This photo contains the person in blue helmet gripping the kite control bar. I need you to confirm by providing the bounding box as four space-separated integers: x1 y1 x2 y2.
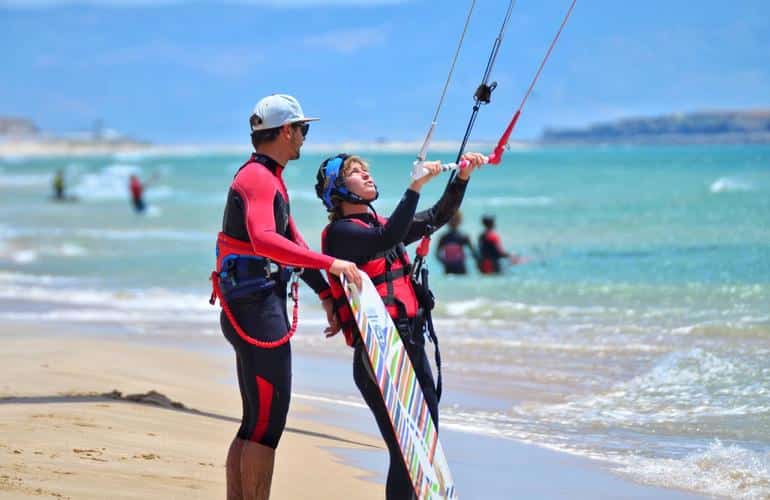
316 153 484 500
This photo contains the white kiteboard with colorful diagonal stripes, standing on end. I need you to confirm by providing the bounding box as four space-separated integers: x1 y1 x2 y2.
343 273 457 499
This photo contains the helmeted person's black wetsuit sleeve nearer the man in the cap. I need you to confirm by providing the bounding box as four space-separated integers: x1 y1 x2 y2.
326 189 420 263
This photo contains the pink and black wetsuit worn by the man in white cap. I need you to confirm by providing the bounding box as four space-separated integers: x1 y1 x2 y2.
220 154 334 448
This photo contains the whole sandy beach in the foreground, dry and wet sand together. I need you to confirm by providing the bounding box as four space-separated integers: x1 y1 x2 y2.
0 316 695 500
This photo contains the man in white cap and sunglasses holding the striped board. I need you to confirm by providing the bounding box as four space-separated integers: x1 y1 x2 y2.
212 95 361 500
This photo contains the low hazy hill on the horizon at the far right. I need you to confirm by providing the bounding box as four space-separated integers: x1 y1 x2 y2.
541 110 770 144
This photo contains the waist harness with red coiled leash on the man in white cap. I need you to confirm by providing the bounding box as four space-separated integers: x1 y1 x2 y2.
209 232 302 349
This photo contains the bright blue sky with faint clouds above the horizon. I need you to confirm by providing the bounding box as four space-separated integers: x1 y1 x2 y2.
0 0 770 144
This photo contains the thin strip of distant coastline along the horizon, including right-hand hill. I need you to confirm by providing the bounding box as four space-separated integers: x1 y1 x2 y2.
6 109 770 157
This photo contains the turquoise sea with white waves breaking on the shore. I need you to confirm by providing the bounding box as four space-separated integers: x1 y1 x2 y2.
0 146 770 498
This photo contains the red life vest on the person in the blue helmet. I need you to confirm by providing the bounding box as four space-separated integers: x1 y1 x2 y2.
321 217 419 346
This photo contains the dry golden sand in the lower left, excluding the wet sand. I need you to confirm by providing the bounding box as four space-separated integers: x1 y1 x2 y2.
0 327 381 499
